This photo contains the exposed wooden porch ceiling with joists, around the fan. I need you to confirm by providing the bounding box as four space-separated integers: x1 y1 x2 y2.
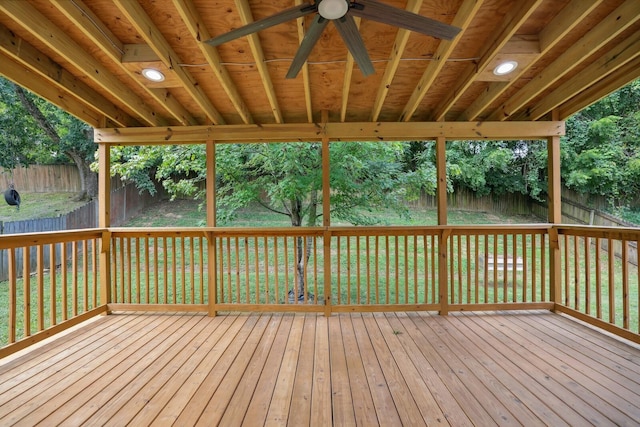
0 0 640 127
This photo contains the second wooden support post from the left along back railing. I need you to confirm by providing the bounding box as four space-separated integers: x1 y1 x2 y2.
206 141 218 316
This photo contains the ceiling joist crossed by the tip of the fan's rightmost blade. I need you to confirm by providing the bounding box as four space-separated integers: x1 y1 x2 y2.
399 0 484 122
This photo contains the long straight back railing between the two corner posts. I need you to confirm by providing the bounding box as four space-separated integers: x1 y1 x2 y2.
111 225 552 313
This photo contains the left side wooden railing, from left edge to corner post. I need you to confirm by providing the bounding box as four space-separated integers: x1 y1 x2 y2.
0 230 106 357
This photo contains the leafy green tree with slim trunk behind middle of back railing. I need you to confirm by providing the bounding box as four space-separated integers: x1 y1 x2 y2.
112 142 436 298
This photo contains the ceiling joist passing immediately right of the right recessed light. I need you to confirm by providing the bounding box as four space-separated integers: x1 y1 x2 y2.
458 0 604 121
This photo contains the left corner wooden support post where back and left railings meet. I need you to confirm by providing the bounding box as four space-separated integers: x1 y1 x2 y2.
98 144 112 314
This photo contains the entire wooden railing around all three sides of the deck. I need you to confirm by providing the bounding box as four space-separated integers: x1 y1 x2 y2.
0 224 640 356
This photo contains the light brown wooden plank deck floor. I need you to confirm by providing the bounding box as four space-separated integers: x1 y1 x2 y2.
0 311 640 426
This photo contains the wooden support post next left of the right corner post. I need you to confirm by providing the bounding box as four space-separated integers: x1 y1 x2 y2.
436 137 451 316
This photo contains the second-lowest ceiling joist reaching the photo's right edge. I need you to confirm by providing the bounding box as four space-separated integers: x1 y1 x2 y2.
515 31 640 120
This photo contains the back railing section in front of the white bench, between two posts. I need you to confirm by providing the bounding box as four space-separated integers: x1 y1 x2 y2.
447 225 551 310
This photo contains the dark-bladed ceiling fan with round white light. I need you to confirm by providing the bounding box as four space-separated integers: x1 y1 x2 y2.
205 0 460 79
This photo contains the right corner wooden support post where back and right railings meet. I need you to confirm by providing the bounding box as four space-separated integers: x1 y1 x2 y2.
547 120 562 304
